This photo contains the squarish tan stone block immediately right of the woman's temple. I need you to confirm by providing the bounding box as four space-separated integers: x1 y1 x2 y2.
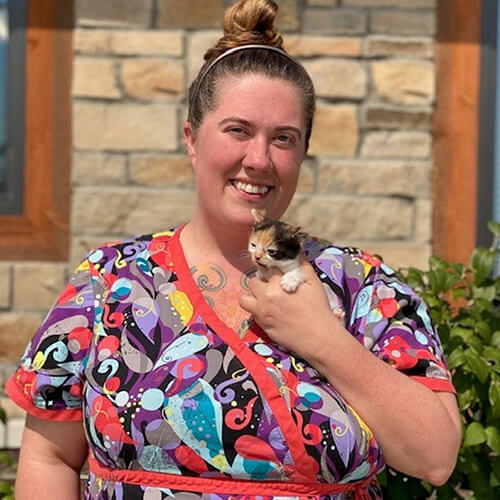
309 104 359 156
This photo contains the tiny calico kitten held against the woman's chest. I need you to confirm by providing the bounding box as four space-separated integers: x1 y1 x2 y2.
248 208 307 293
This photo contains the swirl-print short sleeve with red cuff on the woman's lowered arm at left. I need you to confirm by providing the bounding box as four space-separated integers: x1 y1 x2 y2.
6 254 99 421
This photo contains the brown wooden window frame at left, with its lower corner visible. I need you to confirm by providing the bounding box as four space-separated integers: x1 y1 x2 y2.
0 0 74 261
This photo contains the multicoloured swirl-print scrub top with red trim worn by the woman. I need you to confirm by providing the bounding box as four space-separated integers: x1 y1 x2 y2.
7 228 454 500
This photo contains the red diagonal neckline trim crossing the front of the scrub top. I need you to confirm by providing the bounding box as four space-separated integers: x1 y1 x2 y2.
170 226 318 482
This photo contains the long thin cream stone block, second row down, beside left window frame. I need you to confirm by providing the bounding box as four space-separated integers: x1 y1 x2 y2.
73 28 184 57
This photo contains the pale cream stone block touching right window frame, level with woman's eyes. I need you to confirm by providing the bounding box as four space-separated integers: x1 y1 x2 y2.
361 131 431 159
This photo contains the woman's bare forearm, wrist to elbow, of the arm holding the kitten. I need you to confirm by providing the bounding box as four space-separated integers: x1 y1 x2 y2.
308 318 460 483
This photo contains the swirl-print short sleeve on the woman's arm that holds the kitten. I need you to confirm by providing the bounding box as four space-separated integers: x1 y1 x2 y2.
348 254 456 393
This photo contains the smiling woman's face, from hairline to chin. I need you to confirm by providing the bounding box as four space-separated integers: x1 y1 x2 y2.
184 74 306 229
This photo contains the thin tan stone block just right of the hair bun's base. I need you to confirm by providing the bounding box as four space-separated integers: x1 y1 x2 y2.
284 35 362 57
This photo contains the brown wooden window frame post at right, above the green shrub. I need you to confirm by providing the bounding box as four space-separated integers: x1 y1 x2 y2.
432 0 483 264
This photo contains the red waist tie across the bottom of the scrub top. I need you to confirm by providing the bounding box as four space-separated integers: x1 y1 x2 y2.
89 457 375 500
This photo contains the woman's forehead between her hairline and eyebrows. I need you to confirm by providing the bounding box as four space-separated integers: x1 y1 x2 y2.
210 74 304 127
